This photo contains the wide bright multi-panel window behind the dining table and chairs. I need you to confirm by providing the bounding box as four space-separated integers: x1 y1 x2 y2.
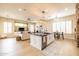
52 21 72 34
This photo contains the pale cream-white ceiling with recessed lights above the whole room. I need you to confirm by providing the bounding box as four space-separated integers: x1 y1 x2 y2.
0 3 76 20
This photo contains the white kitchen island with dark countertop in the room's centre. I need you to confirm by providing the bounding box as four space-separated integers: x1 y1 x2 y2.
30 33 53 50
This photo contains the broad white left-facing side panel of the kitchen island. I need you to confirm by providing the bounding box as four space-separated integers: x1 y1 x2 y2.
30 34 42 50
